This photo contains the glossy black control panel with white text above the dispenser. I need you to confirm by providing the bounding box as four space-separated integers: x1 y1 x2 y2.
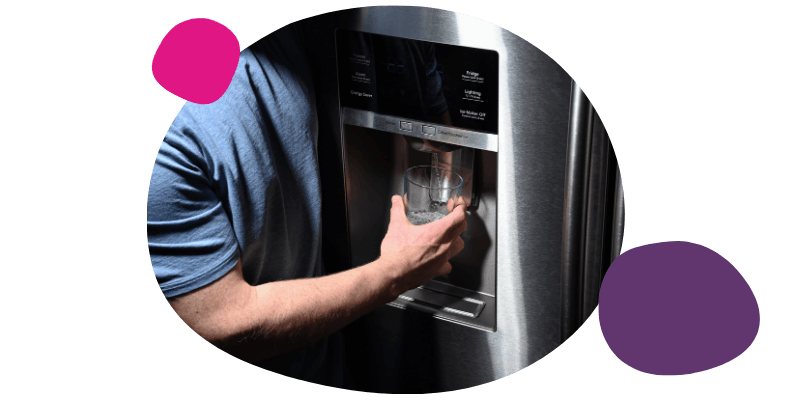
336 29 498 134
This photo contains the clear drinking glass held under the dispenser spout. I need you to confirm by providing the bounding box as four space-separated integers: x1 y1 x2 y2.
403 165 464 225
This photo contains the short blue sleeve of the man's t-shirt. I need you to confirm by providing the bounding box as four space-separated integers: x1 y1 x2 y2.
147 120 239 298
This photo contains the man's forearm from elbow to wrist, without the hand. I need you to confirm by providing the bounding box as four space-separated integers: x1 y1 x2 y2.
215 260 397 362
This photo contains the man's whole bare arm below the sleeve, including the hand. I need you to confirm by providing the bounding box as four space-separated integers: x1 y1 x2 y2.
170 196 466 362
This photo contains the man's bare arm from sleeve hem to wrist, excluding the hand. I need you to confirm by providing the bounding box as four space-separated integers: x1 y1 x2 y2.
170 260 393 362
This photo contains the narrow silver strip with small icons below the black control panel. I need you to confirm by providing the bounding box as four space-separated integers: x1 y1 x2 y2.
342 108 497 152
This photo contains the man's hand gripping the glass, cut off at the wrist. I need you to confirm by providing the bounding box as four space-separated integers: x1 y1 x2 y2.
379 196 467 299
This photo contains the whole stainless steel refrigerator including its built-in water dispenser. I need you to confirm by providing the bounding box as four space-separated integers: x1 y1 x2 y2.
301 7 623 392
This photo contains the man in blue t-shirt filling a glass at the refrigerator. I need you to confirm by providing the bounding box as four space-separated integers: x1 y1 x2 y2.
147 24 466 387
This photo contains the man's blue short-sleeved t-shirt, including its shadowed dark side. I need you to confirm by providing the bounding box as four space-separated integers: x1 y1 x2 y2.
147 24 343 387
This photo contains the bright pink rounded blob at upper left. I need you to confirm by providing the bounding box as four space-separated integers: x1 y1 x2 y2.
153 18 239 104
